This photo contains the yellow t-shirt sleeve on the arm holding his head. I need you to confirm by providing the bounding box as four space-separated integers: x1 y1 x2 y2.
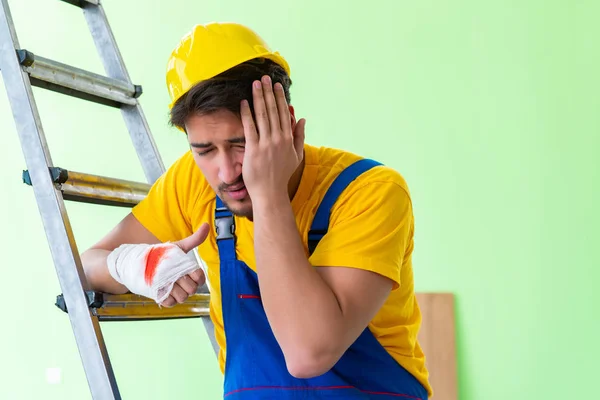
309 176 413 289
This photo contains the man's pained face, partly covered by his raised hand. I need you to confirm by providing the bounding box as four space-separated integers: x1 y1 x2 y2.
185 110 252 218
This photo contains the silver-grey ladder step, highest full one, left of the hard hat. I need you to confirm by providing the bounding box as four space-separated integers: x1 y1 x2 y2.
17 49 142 107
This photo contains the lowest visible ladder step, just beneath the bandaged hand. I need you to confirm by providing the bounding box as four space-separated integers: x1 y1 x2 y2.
56 292 210 321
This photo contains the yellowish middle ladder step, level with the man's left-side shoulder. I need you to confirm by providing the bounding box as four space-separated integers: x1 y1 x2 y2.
23 167 151 207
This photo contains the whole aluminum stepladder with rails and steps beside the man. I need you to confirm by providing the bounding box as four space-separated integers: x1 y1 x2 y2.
0 0 217 400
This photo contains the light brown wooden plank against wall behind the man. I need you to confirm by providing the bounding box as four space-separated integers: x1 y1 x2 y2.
417 293 458 400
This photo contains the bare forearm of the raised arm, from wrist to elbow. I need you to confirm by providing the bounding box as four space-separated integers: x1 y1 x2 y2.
254 196 344 372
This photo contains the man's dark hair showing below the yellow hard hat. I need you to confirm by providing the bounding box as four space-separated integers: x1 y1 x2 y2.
169 58 292 130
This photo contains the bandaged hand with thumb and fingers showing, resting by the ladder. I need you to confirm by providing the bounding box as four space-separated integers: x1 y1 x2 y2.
107 224 209 307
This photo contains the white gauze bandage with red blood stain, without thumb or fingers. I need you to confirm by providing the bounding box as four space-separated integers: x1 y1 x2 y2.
106 243 200 304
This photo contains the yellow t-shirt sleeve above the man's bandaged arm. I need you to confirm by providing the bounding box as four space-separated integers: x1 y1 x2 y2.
132 153 201 242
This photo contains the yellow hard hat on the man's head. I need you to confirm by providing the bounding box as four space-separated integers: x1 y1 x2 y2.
167 22 290 109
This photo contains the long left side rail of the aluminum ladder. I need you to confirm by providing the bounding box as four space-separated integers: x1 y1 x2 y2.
0 0 120 399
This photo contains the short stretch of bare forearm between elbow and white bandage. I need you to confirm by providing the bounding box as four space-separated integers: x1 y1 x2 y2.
81 249 128 294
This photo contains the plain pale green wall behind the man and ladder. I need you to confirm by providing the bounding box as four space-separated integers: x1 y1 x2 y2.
0 0 600 400
